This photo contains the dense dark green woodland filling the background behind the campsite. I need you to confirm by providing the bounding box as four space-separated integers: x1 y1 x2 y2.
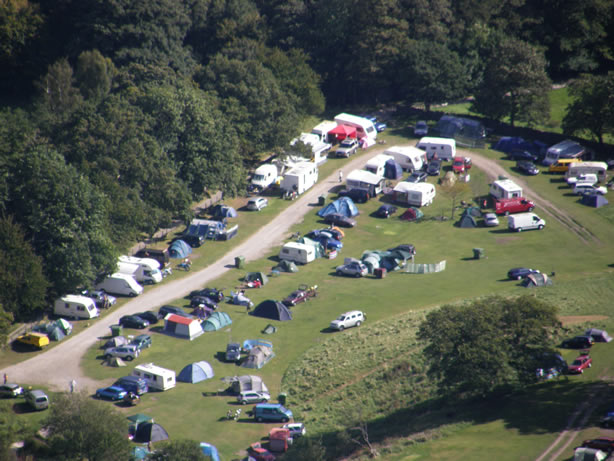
0 0 614 330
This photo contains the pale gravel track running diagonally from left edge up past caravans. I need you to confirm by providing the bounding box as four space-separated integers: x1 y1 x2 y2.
0 146 385 392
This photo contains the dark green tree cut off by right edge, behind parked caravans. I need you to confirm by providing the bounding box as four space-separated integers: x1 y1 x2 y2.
563 72 614 144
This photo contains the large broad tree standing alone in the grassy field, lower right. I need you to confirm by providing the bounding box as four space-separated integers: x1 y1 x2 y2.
418 296 560 397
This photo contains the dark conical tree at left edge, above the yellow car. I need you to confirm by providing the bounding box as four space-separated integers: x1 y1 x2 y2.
0 216 49 320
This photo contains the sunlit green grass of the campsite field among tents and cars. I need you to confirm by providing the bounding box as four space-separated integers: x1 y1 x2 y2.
73 131 614 460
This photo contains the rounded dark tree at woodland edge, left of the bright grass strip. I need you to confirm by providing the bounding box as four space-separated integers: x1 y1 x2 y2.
472 38 550 126
